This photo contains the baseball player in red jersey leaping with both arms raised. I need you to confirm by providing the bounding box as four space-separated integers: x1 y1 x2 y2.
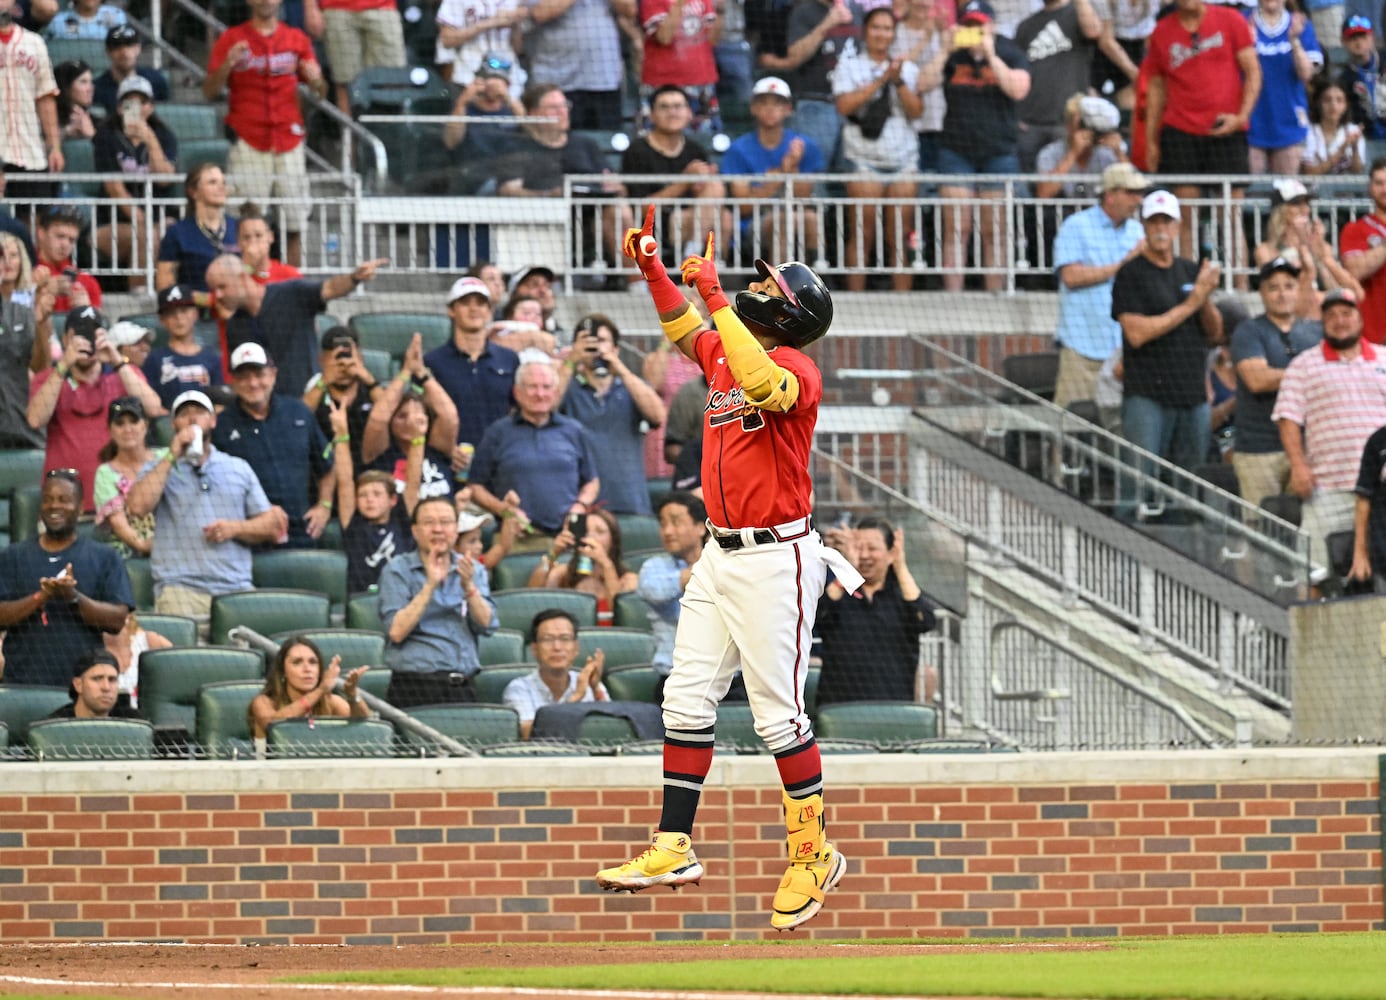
596 206 862 931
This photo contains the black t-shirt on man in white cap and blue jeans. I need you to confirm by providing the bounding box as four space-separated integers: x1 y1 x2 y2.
1112 256 1209 406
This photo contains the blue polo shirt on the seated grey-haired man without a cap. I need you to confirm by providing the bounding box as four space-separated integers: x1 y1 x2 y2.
471 413 597 535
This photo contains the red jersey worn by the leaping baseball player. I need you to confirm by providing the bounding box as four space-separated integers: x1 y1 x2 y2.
693 330 823 528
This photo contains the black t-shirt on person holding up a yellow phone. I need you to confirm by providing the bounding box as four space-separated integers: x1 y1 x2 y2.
938 35 1031 161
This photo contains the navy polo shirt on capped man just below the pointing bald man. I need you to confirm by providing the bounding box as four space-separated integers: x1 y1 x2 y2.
212 395 333 548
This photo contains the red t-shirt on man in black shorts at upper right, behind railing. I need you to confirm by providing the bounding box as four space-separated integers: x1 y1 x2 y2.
1145 4 1256 136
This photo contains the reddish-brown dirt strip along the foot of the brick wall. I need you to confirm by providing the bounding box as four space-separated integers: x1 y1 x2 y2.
0 942 1042 1000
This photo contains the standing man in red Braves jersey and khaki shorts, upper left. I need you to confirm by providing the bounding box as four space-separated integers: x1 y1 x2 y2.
202 0 327 266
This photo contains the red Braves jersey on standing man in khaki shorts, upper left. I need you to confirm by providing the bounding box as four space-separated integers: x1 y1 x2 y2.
208 21 317 152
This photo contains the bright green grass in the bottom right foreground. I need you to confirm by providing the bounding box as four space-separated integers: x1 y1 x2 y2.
289 934 1386 1000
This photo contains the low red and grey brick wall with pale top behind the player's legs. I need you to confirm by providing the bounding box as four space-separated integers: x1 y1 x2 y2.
0 749 1386 943
